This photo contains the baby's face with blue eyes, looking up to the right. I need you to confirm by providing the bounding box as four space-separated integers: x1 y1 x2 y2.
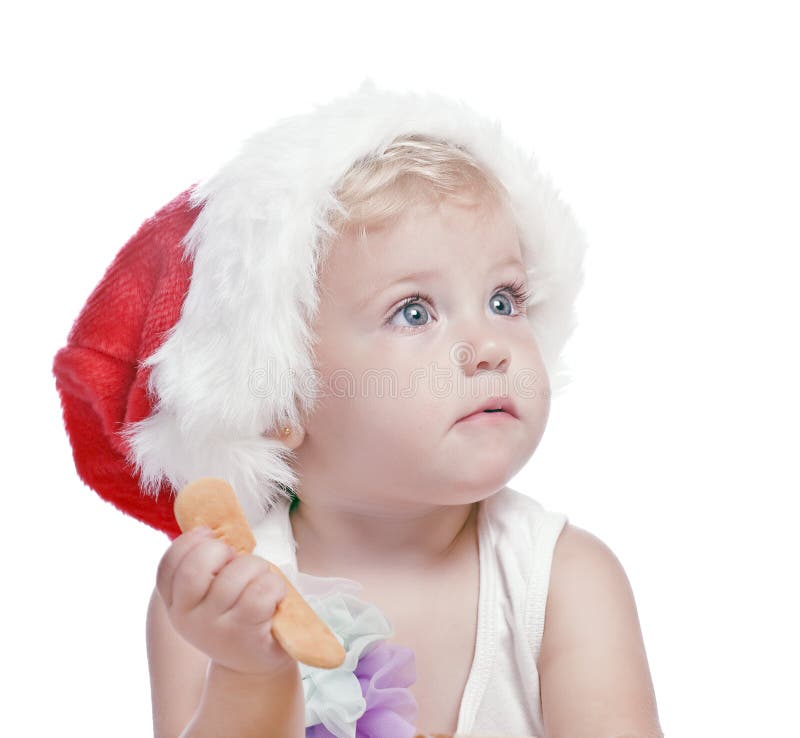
296 193 550 509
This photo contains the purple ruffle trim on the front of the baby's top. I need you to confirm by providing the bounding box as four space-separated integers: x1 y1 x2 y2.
306 641 419 738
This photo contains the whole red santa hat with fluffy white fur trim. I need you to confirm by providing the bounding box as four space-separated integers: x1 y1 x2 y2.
53 79 585 537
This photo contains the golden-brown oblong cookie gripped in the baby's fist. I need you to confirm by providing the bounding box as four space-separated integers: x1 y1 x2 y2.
174 477 346 669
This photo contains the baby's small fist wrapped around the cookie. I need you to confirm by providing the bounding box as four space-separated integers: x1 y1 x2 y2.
156 528 294 674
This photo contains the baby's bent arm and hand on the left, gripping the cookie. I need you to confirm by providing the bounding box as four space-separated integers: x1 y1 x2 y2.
147 532 305 738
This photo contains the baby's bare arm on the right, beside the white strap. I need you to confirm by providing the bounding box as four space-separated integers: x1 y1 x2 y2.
538 524 663 738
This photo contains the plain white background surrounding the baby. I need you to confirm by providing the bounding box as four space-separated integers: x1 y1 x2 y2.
0 0 800 738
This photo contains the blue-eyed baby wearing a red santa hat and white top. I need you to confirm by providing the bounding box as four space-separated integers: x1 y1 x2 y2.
55 82 661 738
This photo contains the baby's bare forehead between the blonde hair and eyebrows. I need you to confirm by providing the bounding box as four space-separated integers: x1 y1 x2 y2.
321 200 522 301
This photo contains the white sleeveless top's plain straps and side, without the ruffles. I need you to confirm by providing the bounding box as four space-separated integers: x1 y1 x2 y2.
253 487 567 736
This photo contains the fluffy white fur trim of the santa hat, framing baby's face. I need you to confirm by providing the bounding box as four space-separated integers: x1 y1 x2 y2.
126 79 585 524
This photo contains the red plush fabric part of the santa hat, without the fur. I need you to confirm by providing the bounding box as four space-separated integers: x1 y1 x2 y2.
53 190 199 539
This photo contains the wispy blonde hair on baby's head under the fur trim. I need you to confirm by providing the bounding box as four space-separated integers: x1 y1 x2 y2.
328 133 508 237
